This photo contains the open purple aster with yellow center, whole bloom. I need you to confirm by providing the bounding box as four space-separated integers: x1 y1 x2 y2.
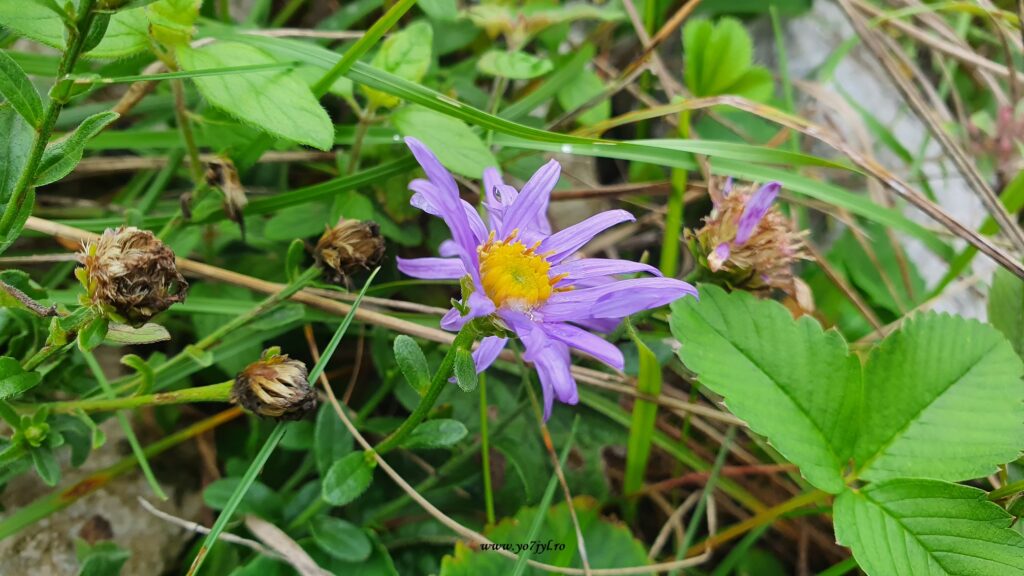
398 138 696 419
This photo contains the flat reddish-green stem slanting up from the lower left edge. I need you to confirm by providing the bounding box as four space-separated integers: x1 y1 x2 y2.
0 407 242 540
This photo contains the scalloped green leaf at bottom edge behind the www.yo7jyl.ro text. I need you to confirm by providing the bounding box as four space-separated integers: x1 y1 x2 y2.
439 496 650 576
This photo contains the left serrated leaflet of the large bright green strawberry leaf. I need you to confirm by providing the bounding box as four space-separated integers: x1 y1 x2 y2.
671 285 861 494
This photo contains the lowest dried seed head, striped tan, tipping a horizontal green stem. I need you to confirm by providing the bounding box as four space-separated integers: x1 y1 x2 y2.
231 347 316 420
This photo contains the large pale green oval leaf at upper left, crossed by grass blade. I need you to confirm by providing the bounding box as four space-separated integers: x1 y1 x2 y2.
177 42 334 150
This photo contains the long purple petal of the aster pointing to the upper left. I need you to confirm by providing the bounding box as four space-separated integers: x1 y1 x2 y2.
406 137 483 280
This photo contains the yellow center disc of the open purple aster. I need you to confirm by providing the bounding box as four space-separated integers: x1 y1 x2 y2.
477 231 569 307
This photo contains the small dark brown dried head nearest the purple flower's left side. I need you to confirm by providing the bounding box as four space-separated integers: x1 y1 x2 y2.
314 218 384 283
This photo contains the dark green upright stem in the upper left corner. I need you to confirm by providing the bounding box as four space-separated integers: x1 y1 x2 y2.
0 0 95 238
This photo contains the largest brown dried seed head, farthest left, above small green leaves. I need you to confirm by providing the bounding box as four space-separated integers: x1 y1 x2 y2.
76 227 188 327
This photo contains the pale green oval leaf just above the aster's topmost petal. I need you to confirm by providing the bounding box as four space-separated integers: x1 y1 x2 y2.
391 106 498 179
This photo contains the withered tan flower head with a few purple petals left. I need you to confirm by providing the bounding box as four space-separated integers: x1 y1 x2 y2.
692 180 813 307
